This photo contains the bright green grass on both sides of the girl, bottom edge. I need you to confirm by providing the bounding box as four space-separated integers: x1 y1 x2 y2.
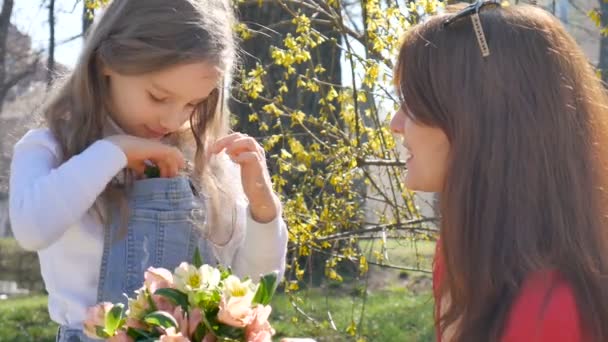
0 288 434 342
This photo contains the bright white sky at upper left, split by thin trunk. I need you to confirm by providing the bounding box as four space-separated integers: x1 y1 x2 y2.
11 0 82 66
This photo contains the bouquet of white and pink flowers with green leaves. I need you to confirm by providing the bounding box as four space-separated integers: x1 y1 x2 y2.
84 251 277 342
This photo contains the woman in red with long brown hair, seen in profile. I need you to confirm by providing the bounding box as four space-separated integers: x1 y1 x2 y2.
391 3 608 342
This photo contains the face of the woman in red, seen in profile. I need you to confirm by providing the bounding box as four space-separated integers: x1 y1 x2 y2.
390 109 450 192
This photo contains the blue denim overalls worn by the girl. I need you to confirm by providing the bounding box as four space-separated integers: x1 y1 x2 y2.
57 178 215 342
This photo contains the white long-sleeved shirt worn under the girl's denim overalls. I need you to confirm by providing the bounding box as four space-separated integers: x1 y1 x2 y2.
9 129 287 328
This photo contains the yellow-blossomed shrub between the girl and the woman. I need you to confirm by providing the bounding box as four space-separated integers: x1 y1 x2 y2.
233 0 439 289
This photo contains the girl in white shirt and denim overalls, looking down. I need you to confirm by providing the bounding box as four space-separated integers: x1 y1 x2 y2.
10 0 287 342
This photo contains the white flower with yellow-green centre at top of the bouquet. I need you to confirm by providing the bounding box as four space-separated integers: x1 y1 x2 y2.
174 262 221 292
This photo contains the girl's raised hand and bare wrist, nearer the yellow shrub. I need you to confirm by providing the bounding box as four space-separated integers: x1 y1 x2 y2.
210 133 280 223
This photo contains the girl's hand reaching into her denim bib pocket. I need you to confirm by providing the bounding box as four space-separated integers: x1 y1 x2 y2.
105 135 185 178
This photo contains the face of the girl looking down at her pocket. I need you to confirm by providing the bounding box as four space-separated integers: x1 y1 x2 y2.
103 62 222 139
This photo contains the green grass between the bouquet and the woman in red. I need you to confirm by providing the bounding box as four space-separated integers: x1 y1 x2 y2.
271 288 435 342
